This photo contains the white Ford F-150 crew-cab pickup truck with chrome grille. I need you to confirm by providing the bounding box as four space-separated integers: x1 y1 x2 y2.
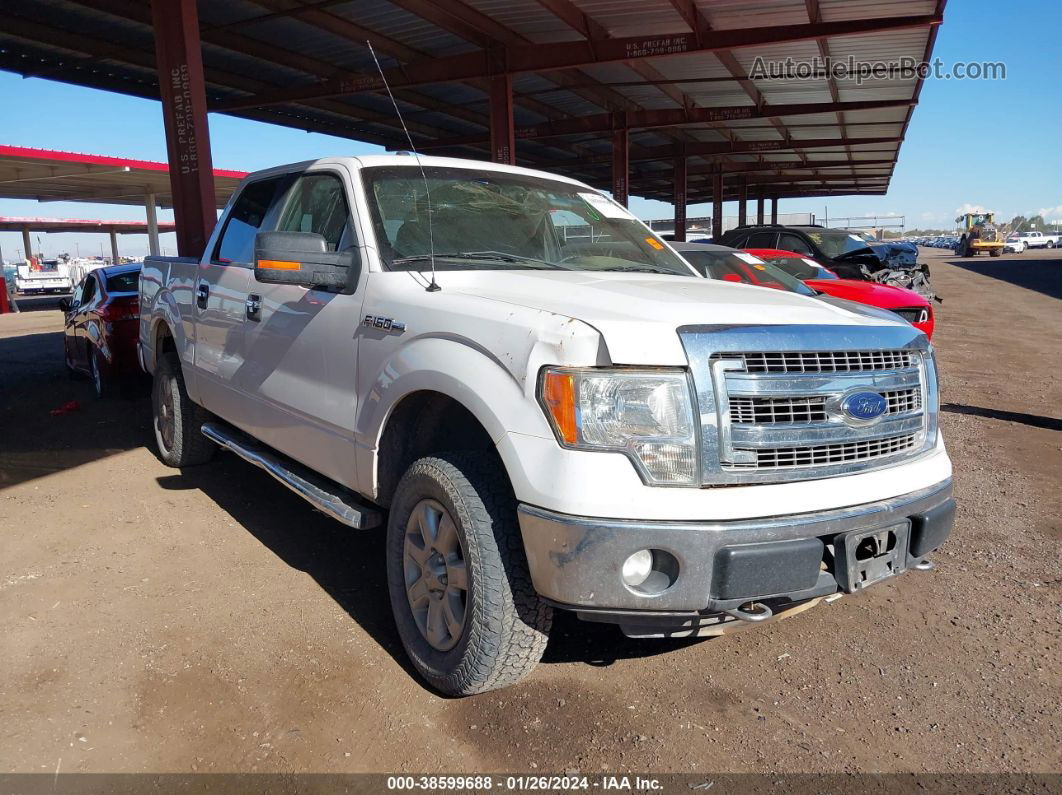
139 155 955 694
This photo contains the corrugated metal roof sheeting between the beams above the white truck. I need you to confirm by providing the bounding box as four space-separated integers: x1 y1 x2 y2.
0 0 944 198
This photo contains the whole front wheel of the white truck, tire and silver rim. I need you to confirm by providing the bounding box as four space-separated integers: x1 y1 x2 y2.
387 452 552 695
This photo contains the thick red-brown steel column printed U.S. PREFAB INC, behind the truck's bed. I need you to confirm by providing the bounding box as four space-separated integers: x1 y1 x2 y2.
151 0 218 257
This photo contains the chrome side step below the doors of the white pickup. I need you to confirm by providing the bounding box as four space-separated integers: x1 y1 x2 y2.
202 422 383 530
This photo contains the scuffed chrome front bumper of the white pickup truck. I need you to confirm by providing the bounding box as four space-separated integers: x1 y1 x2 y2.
519 480 955 621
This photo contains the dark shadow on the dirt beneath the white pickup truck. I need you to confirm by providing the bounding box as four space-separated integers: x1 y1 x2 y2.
157 454 698 684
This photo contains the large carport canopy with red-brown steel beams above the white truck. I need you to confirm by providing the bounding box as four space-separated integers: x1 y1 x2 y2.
0 0 946 246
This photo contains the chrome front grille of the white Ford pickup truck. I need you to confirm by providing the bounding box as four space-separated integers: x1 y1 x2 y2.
679 322 938 487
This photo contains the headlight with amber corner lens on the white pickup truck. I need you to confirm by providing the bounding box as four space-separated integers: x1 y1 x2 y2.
538 367 697 485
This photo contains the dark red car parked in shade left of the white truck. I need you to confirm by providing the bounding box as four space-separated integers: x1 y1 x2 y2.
59 264 140 397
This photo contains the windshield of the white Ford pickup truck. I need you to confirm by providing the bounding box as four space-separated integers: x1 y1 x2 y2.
361 166 695 276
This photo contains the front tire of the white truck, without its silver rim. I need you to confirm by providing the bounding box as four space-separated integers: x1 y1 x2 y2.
387 452 552 695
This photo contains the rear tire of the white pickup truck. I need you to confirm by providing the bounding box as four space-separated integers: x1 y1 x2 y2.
151 353 217 468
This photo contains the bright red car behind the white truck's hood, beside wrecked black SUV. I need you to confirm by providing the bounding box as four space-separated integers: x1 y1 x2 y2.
744 248 935 340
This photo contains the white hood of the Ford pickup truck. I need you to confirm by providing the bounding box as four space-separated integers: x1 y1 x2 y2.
439 271 906 366
